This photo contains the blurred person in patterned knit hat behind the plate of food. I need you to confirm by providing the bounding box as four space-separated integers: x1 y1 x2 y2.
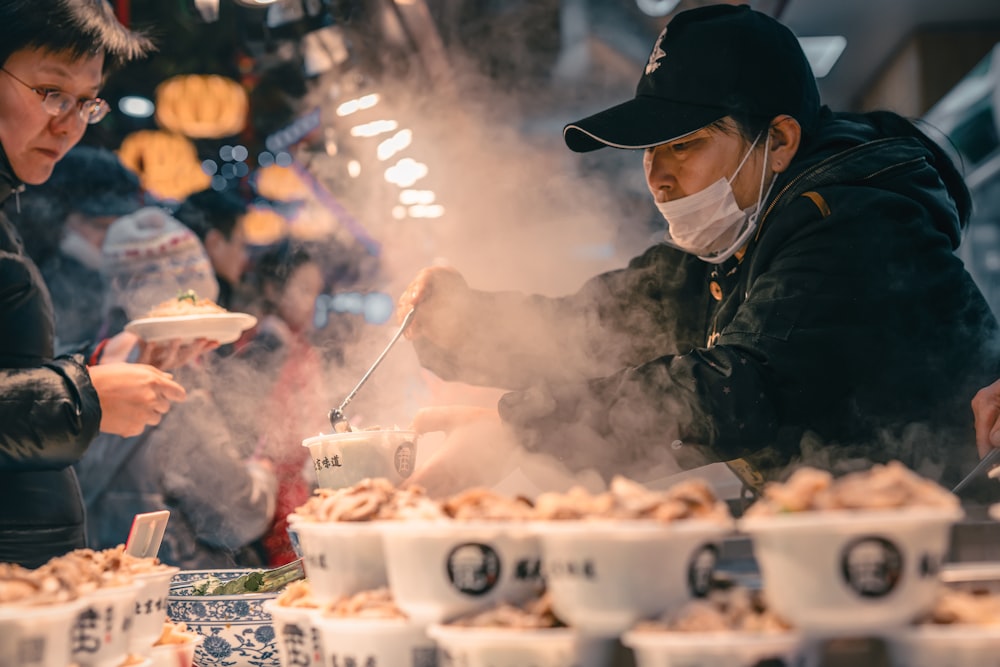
76 207 277 569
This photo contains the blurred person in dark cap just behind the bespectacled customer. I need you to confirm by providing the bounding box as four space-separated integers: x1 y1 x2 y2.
26 146 142 349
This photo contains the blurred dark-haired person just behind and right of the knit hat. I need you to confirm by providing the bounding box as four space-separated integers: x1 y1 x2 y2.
174 189 249 310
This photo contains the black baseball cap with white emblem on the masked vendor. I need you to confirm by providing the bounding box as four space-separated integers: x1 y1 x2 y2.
563 5 820 153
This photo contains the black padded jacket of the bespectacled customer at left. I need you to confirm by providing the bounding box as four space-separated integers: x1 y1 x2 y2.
0 149 101 567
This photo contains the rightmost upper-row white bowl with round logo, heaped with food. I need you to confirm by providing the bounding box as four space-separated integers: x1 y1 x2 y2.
739 463 962 634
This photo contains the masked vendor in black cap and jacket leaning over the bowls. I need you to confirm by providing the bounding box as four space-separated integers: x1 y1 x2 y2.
400 5 997 496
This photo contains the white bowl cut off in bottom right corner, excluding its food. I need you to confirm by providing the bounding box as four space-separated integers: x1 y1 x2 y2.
886 624 1000 667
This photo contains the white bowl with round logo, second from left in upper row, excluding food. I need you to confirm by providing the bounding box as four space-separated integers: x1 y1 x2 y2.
382 520 542 625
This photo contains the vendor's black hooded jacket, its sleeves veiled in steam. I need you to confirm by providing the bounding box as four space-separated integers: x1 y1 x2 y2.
416 110 997 490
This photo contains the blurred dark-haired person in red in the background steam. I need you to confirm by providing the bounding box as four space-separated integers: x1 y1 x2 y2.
220 240 330 567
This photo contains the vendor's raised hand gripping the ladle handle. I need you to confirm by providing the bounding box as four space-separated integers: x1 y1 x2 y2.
396 266 469 345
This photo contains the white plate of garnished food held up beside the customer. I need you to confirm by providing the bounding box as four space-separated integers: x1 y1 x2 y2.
125 290 257 345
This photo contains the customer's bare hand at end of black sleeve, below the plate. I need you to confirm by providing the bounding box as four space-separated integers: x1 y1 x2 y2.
90 363 187 437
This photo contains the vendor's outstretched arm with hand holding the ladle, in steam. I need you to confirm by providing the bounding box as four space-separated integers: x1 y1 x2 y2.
399 246 705 388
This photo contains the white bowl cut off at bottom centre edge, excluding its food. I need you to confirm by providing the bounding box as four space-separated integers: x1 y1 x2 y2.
427 625 582 667
